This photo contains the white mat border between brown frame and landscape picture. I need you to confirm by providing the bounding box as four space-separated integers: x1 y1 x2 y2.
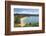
11 5 42 31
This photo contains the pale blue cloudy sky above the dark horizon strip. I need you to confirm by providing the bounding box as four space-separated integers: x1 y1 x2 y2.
14 8 39 14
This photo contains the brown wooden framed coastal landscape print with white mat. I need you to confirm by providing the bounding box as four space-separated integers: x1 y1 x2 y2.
5 1 45 35
